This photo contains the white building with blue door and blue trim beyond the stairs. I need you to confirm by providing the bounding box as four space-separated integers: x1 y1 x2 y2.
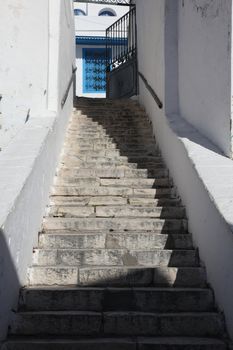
74 1 129 97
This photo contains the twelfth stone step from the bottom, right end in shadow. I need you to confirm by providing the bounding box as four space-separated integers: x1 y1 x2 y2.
58 166 169 178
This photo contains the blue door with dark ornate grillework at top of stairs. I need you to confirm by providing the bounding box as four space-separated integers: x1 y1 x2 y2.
83 48 106 93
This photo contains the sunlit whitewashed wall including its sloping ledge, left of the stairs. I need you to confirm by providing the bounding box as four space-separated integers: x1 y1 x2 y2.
0 0 75 340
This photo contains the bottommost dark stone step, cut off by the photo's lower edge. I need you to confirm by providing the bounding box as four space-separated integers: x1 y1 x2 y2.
2 337 228 350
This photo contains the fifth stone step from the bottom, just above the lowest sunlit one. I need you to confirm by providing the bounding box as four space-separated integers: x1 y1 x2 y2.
33 248 199 267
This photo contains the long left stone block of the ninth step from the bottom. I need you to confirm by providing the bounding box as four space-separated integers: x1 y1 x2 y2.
50 196 128 206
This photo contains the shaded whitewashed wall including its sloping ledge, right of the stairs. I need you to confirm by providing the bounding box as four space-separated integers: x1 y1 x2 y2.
135 0 233 337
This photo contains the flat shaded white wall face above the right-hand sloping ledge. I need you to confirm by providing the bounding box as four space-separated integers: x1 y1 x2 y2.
178 0 232 156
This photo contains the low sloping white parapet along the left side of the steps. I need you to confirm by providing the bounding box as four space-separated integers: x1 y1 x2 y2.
0 98 72 341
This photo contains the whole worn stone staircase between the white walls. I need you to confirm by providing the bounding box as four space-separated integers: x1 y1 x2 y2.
3 99 228 350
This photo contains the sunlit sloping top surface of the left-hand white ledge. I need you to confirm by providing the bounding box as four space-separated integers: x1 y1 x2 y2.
0 117 56 227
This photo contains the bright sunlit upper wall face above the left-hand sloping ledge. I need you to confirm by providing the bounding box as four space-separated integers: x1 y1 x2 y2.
0 0 49 148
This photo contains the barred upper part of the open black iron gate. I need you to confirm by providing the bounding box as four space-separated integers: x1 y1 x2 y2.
106 7 137 72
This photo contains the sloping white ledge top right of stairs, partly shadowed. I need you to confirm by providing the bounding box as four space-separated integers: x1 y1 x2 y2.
167 114 233 232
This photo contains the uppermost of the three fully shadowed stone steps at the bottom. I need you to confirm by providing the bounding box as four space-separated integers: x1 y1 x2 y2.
19 287 214 312
